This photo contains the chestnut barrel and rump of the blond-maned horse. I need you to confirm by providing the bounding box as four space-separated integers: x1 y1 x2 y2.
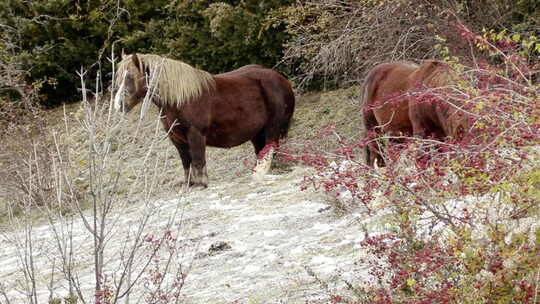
194 65 294 147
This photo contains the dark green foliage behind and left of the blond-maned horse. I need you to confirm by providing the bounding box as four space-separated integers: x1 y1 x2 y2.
0 0 291 106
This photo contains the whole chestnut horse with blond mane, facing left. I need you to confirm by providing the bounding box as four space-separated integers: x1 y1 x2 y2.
114 54 295 187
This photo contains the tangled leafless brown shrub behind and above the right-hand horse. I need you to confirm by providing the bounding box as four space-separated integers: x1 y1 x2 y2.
276 0 536 88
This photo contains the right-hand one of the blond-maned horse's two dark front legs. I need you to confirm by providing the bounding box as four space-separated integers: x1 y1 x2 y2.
187 127 208 188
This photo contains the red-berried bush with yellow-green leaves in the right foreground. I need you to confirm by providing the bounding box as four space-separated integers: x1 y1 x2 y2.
281 24 540 303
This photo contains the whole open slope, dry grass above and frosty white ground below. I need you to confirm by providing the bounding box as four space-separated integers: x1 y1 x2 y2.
0 88 371 303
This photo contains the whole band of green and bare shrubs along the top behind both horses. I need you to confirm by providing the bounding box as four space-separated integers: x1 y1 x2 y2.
0 0 540 107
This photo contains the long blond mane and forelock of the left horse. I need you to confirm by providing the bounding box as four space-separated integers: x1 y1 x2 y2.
115 54 215 107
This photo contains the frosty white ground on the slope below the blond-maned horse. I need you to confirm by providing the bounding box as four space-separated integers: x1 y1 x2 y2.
0 168 384 303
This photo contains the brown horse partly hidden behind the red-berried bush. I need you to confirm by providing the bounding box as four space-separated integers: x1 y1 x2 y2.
360 60 468 166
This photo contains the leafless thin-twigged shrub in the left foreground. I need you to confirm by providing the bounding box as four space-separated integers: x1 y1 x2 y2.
0 51 191 303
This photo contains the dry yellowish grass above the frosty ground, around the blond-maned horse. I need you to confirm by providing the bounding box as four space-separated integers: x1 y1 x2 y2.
0 86 360 222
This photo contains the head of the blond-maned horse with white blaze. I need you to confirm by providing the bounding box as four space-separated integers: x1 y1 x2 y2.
114 54 148 112
